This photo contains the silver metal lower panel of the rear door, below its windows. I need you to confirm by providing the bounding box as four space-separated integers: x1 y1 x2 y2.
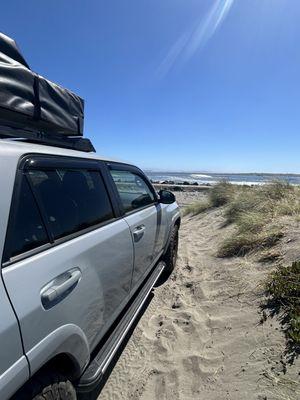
3 219 133 353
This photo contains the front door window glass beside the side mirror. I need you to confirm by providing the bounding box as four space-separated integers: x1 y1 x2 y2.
110 169 155 212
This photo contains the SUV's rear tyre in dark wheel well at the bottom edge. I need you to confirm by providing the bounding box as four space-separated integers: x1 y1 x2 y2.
12 371 77 400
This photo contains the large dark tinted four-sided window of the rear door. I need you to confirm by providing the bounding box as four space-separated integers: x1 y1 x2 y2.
29 169 113 239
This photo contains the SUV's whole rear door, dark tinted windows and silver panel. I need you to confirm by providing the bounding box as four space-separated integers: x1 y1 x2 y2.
3 157 133 372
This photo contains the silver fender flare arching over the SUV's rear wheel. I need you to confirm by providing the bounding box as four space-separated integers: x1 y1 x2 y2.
26 324 90 377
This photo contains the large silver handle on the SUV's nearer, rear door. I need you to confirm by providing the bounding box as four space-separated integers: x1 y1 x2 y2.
41 268 81 309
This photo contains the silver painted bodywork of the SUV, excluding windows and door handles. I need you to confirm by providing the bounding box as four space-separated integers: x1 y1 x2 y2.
0 140 180 400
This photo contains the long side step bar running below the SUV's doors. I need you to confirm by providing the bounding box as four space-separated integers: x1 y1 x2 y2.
77 262 165 393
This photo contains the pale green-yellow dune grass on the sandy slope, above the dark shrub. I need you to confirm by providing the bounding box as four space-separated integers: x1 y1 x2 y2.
184 182 300 257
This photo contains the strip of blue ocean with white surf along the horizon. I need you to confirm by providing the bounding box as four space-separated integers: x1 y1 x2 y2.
145 171 300 185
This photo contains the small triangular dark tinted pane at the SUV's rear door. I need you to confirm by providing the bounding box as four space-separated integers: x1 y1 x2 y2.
4 175 49 262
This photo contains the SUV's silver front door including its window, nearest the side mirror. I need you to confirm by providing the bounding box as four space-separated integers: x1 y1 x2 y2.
108 163 163 288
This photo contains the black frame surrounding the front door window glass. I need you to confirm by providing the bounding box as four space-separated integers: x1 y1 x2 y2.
106 162 159 216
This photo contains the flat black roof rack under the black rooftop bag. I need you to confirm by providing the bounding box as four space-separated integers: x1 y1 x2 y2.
0 125 96 153
